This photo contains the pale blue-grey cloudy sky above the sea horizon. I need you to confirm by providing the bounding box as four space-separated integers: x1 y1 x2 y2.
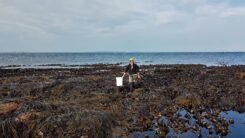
0 0 245 52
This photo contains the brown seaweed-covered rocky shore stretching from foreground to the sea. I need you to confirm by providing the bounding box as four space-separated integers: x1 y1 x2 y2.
0 64 245 138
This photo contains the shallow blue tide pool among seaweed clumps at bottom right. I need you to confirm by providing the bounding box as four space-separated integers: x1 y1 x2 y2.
129 109 245 138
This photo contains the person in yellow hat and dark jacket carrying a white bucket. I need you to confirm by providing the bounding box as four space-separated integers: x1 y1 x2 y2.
122 58 140 92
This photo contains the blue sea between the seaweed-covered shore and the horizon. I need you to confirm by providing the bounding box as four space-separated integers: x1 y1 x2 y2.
0 52 245 68
